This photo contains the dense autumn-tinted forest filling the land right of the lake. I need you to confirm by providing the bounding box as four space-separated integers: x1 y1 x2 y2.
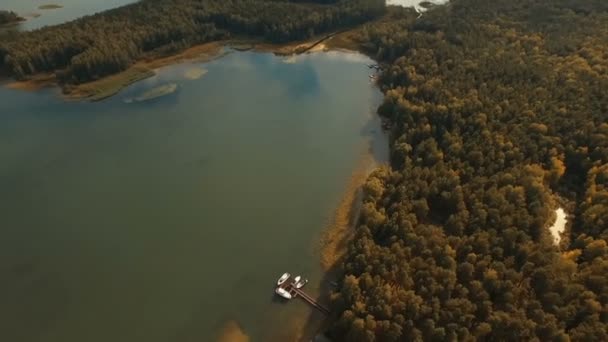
330 0 608 341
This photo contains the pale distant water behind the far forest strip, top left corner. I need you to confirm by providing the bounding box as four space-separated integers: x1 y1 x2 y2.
0 0 137 30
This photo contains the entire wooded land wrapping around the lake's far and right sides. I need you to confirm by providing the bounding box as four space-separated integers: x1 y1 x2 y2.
0 0 608 341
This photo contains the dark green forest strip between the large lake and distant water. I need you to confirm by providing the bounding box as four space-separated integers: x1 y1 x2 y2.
0 0 384 84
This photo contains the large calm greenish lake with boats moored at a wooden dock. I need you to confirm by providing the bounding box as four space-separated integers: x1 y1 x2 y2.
0 52 388 342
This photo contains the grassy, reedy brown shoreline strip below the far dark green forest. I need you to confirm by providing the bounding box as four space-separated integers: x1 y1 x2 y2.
0 27 363 102
